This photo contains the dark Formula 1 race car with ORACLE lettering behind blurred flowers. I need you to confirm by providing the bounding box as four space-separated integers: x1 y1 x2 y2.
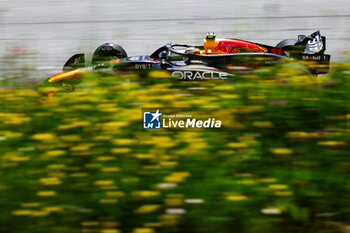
48 31 330 83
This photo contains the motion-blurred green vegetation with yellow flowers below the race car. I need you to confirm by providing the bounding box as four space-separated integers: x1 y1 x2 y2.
0 64 350 233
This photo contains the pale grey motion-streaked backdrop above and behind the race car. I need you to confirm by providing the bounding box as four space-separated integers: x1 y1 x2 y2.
0 0 350 74
